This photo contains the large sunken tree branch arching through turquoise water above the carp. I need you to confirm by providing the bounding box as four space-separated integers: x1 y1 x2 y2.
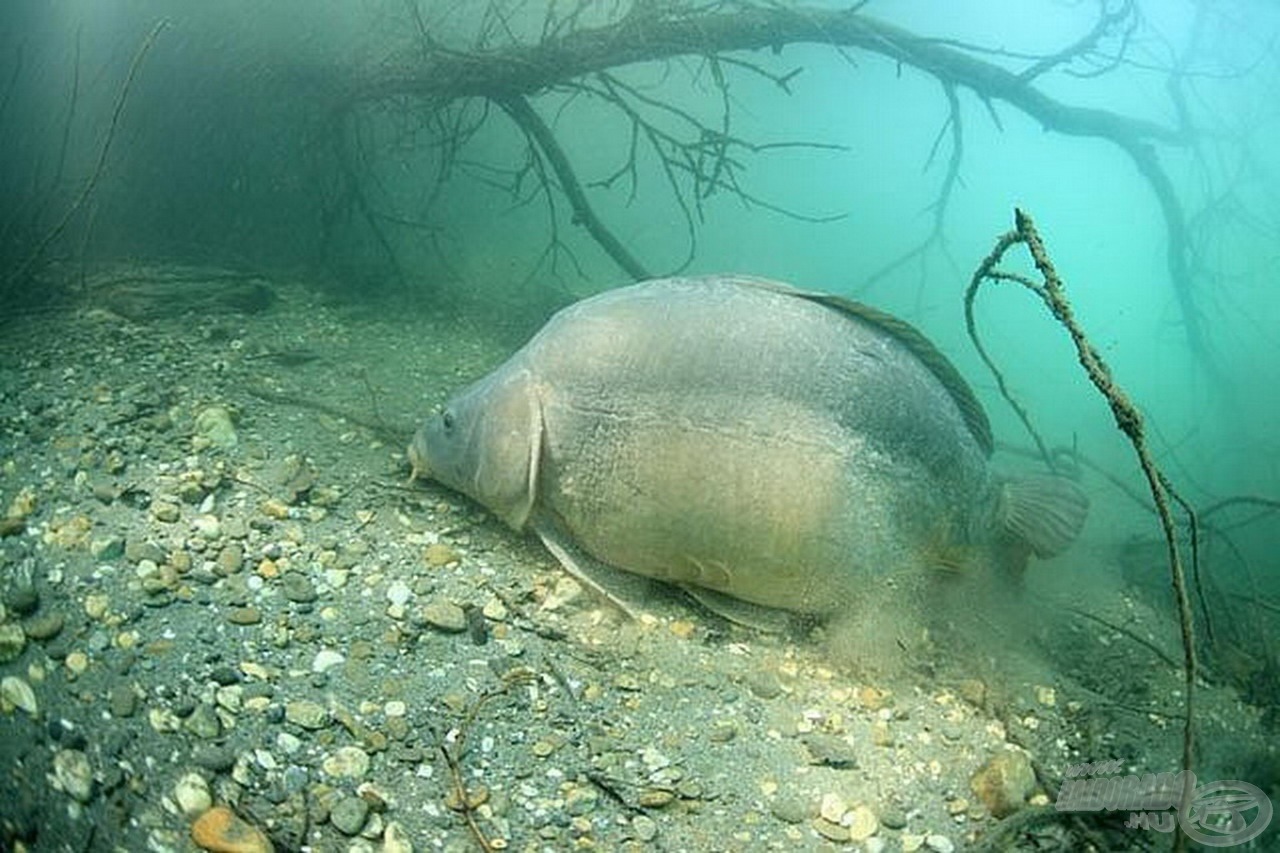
346 0 1207 356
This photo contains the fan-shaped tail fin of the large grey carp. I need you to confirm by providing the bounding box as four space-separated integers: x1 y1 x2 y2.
1000 475 1089 557
